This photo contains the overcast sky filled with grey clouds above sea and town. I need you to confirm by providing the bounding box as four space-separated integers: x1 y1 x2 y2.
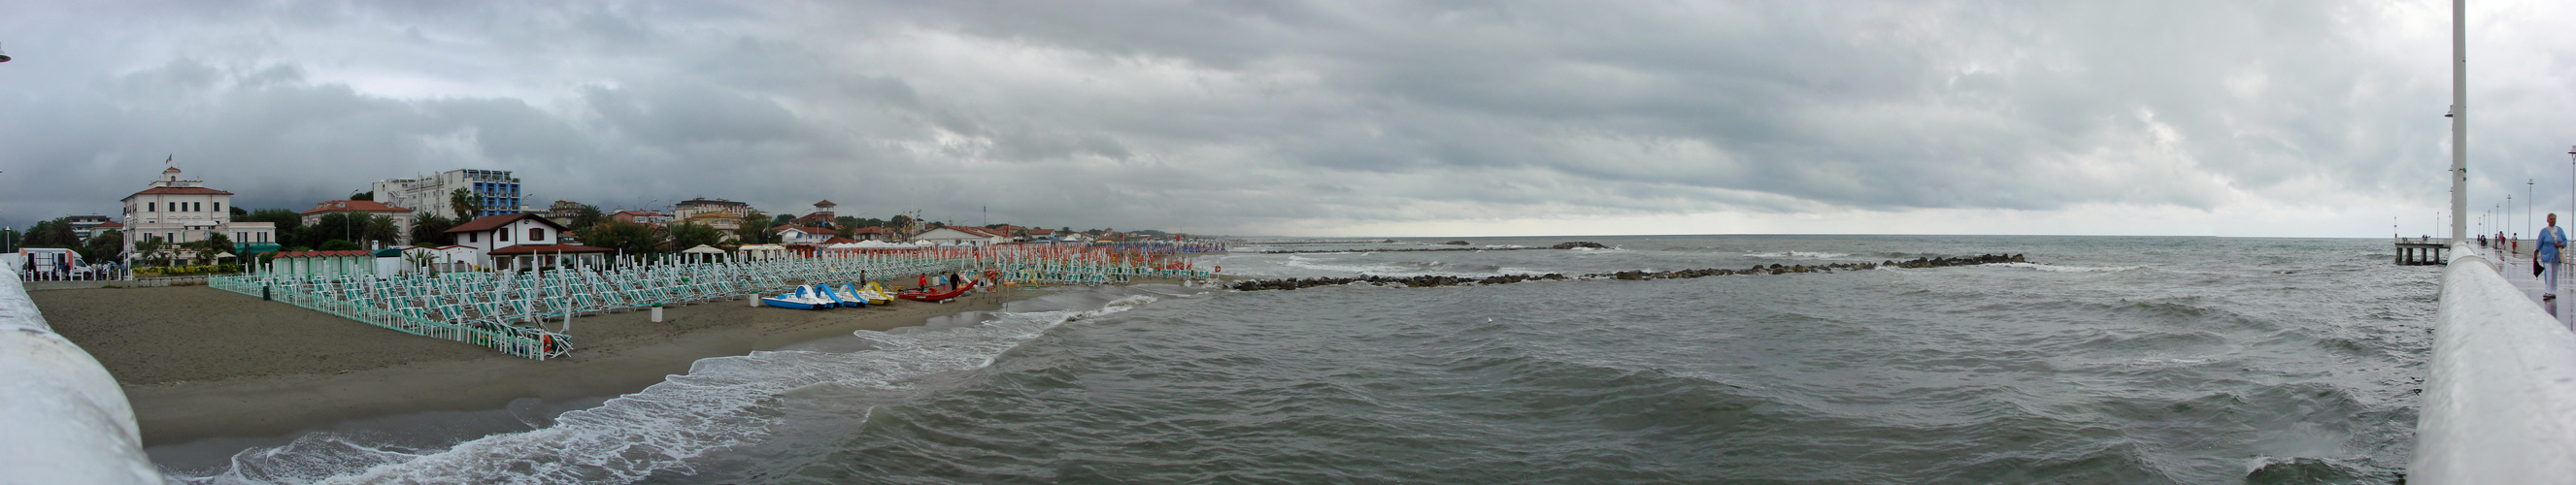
0 0 2576 238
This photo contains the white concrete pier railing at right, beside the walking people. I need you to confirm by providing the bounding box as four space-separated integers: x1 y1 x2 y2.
2406 245 2576 485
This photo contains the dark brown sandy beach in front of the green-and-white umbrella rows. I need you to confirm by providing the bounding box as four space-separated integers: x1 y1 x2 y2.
28 286 1038 446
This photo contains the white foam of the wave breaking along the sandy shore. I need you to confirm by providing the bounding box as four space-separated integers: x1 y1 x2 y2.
181 289 1180 485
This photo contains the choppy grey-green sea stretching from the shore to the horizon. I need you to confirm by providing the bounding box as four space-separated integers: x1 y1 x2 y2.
154 238 2437 482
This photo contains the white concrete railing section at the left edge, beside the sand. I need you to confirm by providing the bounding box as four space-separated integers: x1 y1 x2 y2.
0 263 162 482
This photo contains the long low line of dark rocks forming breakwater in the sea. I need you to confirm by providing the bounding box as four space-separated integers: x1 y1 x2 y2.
1226 253 2030 292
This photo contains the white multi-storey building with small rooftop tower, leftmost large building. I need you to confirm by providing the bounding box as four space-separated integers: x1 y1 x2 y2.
123 168 279 261
